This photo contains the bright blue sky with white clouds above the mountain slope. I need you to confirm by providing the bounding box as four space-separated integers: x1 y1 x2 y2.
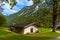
2 0 33 15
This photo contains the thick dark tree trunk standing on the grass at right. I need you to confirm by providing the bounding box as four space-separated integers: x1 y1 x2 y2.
52 0 58 32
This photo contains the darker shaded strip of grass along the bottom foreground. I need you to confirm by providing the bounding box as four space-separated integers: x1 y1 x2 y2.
0 35 52 40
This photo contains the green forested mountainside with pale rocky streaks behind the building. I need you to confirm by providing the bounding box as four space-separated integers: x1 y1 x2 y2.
7 0 60 27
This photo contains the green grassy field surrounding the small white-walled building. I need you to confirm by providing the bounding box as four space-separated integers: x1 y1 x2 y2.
0 28 60 40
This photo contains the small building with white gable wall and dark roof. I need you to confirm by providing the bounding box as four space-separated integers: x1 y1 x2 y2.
10 23 38 34
